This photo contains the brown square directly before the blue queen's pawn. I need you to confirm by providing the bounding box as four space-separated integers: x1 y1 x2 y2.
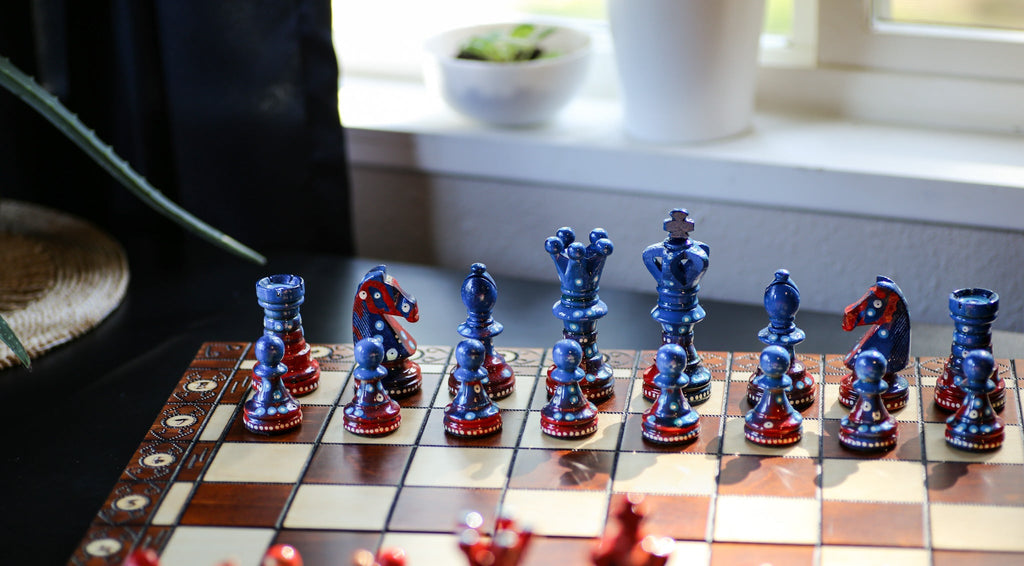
508 449 615 490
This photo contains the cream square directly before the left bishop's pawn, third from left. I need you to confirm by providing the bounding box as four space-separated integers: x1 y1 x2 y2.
406 446 514 488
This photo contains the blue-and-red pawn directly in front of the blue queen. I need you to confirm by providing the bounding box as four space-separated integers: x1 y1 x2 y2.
541 339 597 438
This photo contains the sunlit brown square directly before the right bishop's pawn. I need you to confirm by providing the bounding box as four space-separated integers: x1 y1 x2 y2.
718 455 818 497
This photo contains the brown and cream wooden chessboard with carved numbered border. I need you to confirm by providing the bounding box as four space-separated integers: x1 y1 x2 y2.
70 343 1024 566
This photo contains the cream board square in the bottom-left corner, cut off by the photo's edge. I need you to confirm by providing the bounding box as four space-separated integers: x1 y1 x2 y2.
160 527 274 566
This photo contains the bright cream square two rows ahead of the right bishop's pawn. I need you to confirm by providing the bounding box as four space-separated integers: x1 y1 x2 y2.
715 495 821 545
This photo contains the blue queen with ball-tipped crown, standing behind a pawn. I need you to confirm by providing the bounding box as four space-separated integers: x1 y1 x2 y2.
544 227 615 402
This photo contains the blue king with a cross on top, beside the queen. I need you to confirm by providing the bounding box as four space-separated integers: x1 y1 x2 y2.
643 209 711 404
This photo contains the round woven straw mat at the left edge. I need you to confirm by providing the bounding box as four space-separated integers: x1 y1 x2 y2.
0 200 128 368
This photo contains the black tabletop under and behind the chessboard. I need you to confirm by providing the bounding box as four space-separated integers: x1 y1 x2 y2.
0 240 1024 564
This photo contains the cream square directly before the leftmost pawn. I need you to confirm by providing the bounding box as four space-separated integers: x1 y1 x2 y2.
204 442 313 483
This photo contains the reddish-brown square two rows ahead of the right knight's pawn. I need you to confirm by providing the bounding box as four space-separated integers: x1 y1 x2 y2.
821 500 925 548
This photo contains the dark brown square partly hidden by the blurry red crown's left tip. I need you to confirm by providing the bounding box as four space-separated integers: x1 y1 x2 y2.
388 487 502 533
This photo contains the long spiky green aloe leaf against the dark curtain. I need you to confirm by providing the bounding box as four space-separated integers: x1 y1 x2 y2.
0 57 266 264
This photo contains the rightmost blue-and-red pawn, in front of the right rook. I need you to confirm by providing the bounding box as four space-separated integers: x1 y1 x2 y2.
946 349 1006 452
